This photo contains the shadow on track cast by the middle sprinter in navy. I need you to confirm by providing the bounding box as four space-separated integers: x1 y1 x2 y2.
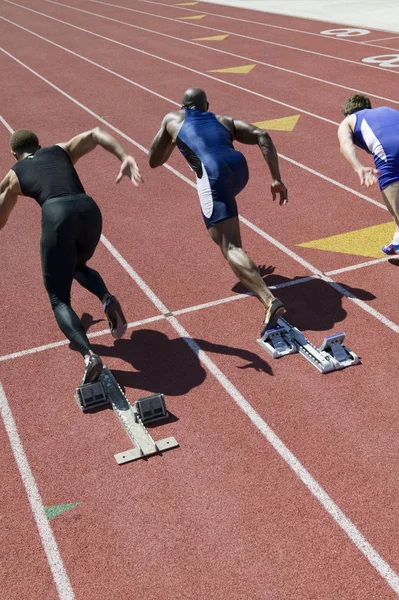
232 266 375 331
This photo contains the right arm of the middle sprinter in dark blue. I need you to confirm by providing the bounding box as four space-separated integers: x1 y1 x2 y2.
225 119 288 205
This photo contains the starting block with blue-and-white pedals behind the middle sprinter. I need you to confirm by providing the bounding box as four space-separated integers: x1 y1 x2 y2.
257 317 360 373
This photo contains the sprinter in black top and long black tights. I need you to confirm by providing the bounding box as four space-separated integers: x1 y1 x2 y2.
0 127 142 384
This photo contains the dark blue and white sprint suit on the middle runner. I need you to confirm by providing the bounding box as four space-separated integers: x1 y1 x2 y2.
176 108 249 229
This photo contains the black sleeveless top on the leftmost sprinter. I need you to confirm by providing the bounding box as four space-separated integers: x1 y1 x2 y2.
12 146 85 206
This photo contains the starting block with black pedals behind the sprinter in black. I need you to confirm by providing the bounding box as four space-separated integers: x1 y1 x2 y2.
75 365 179 465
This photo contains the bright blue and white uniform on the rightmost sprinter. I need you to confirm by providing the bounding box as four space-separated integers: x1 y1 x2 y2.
353 106 399 190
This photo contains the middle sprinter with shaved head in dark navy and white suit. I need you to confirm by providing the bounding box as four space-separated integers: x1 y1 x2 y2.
149 88 287 336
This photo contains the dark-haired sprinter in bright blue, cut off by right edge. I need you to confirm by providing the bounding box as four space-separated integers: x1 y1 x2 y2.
338 94 399 255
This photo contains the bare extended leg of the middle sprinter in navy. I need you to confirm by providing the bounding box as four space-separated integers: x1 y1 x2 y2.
208 217 282 311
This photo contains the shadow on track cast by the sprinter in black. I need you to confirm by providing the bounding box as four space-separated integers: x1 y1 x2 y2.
74 326 273 396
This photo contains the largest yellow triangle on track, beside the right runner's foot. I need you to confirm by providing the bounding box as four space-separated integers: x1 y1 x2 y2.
297 221 395 258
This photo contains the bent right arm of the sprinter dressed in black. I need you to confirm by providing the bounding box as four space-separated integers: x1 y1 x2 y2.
58 127 143 186
